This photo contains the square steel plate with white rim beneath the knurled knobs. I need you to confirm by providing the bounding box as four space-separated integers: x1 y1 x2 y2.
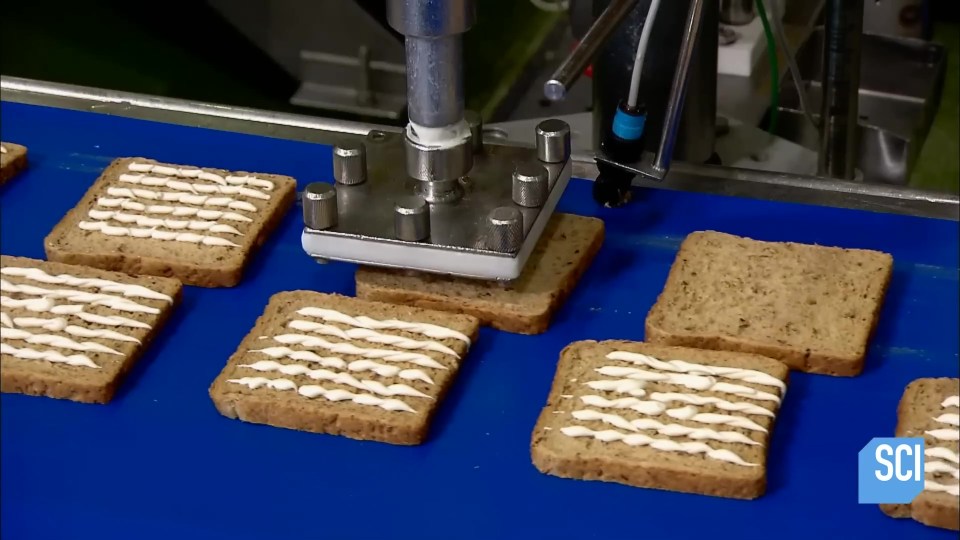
302 124 572 280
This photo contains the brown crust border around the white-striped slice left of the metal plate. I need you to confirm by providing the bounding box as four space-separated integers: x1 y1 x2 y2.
44 158 296 287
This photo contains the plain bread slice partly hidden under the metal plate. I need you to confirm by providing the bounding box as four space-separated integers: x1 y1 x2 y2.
356 214 604 334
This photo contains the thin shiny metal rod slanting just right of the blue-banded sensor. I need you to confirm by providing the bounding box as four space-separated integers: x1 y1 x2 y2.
652 0 704 178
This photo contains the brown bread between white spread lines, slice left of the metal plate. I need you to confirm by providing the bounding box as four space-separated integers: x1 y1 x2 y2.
44 158 296 287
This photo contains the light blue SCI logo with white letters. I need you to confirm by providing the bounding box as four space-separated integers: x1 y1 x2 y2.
857 437 924 504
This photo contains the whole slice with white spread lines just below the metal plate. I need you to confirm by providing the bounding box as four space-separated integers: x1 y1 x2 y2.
210 291 480 445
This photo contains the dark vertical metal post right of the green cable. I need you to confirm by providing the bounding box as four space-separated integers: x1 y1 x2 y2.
817 0 863 180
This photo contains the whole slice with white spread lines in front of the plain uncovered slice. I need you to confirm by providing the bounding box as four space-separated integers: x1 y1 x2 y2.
531 341 788 499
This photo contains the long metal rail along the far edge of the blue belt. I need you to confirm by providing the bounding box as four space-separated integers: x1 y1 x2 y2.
0 75 960 221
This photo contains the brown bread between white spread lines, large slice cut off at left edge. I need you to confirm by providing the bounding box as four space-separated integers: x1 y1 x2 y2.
0 255 181 403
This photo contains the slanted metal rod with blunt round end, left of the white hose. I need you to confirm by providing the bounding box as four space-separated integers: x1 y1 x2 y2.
543 0 637 101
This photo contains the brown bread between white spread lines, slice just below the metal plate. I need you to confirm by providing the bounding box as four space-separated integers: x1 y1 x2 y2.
210 291 480 445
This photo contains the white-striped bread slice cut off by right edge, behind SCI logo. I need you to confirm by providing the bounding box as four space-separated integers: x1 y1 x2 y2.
880 378 960 531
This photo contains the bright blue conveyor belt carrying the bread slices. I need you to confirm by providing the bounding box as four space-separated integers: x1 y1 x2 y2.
0 103 960 540
